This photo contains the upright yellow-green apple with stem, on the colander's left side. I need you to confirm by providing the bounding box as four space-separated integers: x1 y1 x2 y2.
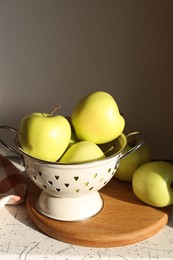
18 113 71 162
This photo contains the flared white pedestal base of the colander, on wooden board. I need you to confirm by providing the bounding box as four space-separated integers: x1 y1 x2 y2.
37 191 103 221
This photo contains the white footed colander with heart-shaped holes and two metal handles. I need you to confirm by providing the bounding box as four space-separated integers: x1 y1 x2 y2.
0 126 146 221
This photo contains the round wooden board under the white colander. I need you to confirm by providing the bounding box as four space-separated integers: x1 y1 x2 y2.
26 178 171 247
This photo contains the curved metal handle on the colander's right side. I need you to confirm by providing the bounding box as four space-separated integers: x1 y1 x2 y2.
119 131 147 160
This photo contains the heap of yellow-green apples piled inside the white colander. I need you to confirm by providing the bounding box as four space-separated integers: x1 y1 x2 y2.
18 91 125 163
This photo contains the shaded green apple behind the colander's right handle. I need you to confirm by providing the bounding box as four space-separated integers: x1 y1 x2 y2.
114 142 152 182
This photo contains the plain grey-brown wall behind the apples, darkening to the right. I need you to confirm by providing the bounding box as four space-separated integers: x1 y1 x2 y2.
0 0 173 159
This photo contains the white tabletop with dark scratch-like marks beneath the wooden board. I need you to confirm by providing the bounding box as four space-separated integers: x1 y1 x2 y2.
0 157 173 260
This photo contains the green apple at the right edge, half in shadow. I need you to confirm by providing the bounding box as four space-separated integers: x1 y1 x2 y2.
132 161 173 207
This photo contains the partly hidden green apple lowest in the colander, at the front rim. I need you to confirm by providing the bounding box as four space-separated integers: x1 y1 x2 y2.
59 141 106 163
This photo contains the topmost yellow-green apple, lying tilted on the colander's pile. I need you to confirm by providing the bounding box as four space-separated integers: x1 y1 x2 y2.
71 91 125 144
